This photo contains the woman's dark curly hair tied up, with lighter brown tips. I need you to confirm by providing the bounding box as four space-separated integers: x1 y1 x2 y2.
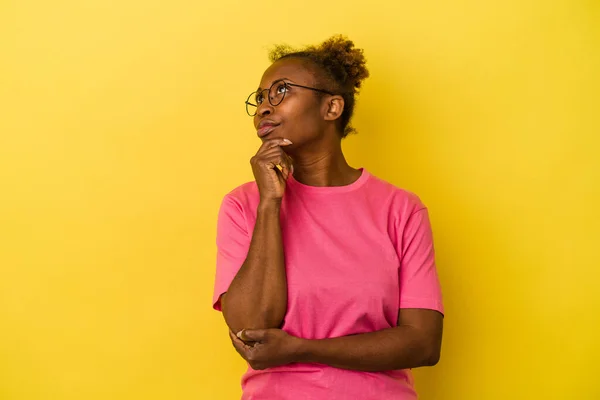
269 35 369 138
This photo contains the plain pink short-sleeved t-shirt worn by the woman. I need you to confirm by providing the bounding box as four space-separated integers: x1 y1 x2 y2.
213 168 444 400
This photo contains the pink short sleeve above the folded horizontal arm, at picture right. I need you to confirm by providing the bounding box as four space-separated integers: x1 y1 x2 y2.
399 208 444 314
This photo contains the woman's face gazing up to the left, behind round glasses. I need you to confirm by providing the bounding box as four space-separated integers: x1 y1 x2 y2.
254 58 327 147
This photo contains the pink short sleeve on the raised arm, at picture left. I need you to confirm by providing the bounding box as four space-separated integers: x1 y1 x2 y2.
213 195 251 311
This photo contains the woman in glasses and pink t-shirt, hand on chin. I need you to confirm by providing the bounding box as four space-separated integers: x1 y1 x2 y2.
213 36 443 400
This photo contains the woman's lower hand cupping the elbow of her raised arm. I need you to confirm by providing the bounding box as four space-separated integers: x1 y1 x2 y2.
229 329 302 370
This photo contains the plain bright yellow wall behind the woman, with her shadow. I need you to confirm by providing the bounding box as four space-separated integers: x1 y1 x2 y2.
0 0 600 400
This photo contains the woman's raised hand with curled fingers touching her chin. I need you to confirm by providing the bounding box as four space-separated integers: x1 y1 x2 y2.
250 139 293 201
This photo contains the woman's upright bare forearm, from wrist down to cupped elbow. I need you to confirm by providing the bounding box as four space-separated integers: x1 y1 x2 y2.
222 201 287 332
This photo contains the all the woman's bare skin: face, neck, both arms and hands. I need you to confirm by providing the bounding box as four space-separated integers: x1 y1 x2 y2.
221 58 443 371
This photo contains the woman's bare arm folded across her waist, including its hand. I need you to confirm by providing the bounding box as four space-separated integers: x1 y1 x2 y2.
231 309 443 372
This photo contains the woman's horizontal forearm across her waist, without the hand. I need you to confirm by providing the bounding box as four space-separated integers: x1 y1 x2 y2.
296 326 441 372
